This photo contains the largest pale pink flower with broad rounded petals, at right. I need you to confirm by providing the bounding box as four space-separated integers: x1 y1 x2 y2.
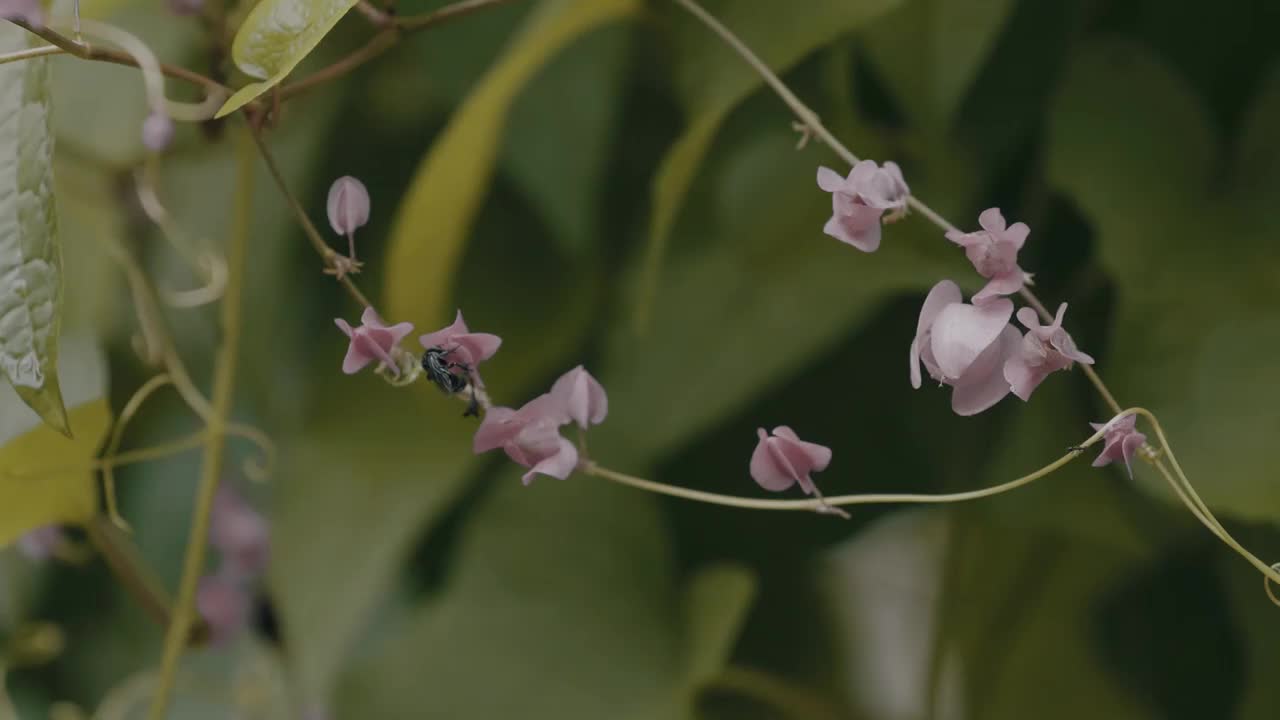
910 281 1021 415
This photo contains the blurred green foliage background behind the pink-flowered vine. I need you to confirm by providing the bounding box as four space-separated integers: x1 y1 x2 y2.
0 0 1280 720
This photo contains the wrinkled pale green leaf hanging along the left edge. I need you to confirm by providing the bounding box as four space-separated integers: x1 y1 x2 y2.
0 23 70 434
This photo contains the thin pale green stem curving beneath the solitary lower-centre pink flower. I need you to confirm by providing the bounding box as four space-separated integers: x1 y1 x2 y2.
579 407 1111 512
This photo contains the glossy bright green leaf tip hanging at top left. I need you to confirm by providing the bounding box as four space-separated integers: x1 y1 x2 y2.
215 0 357 118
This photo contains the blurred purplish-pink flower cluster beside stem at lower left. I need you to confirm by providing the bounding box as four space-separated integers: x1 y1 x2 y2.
196 483 264 643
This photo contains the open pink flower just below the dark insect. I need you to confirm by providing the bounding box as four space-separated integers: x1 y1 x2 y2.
472 393 577 486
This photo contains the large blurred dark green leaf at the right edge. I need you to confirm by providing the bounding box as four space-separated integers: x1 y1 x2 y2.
1050 42 1280 520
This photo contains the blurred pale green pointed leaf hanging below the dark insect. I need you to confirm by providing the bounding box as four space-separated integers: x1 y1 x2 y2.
271 381 475 701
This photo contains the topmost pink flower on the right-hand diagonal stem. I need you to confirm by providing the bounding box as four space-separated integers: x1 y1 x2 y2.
818 160 910 252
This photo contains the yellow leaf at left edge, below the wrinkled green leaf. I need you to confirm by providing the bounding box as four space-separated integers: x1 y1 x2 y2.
0 398 111 546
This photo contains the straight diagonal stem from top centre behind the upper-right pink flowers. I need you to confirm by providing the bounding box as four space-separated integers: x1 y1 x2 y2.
673 0 1120 413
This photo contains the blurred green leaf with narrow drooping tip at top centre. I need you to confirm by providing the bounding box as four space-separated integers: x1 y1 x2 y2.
635 0 900 331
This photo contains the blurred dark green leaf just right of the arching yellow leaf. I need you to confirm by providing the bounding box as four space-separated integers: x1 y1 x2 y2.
503 27 630 256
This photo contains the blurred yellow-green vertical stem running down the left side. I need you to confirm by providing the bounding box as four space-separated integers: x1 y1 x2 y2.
147 128 253 720
